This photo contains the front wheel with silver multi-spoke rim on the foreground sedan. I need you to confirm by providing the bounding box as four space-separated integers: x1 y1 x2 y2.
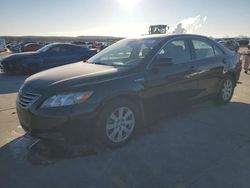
96 99 140 147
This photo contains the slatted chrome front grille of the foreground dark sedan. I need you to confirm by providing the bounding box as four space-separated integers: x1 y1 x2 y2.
18 93 41 108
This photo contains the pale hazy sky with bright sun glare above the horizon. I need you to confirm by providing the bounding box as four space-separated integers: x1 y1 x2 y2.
0 0 250 37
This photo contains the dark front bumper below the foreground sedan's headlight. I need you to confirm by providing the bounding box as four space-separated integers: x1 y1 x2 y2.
16 103 97 142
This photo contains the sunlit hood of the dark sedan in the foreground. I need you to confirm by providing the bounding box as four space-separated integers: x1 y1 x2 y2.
24 62 126 91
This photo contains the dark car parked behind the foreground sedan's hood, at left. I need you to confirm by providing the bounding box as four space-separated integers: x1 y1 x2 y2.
0 43 97 74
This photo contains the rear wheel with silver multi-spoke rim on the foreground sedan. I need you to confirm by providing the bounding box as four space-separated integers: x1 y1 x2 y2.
215 75 235 104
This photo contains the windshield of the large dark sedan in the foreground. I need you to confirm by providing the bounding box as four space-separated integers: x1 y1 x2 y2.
88 38 161 66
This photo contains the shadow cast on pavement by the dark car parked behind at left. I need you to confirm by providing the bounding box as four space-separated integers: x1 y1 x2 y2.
0 73 28 94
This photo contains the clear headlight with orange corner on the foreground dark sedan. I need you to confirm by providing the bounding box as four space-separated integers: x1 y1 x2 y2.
41 91 93 108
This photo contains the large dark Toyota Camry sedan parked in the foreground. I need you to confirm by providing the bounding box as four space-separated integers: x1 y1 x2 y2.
17 35 241 146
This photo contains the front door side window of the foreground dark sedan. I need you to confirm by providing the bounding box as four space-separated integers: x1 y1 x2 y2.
156 39 191 64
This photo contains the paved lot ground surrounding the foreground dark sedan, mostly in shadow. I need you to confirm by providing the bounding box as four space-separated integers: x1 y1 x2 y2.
0 51 250 188
